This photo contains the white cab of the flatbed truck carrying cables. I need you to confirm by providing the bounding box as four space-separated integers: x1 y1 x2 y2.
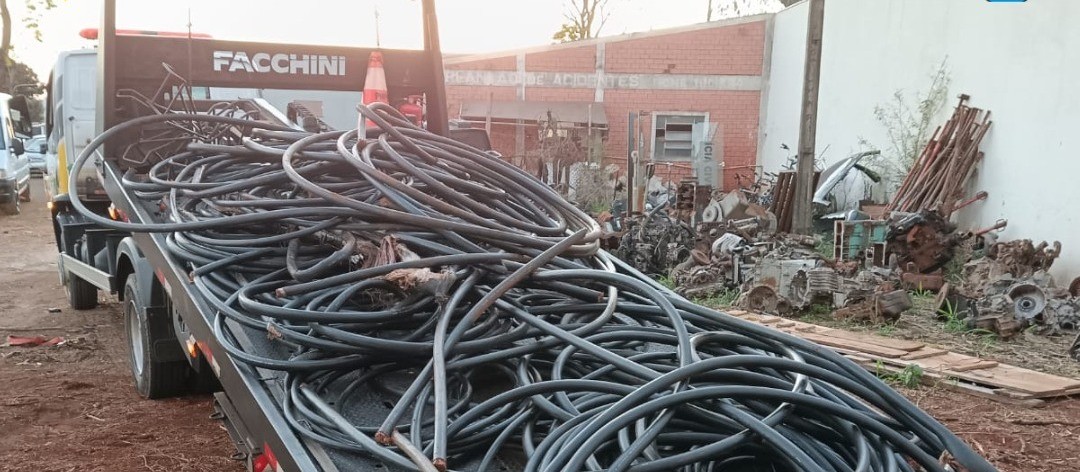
44 49 105 202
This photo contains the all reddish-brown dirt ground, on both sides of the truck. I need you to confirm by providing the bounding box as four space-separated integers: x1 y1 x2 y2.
0 180 1080 472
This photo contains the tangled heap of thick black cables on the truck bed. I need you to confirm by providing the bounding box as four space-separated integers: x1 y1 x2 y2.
72 105 994 471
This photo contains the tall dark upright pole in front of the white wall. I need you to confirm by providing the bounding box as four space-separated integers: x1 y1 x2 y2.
792 0 825 234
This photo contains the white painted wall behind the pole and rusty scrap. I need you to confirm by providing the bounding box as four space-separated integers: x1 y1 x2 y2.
758 0 1080 278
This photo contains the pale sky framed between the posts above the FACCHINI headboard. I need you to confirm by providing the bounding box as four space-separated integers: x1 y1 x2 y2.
117 0 423 50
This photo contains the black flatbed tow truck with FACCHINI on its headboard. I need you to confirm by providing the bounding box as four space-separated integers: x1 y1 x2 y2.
46 0 460 472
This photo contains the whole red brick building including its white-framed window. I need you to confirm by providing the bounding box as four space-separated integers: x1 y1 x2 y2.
445 15 772 189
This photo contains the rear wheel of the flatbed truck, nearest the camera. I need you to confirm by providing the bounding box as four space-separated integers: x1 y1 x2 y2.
124 277 191 399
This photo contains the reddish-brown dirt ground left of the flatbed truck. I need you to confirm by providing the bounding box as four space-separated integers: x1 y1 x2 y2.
0 179 235 472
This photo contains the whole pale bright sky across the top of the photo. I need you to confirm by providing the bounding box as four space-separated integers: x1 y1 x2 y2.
9 0 781 81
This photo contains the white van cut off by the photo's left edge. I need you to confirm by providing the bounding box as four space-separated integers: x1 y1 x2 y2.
0 93 30 215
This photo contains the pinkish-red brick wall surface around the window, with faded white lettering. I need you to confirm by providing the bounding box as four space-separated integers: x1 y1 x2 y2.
446 15 771 188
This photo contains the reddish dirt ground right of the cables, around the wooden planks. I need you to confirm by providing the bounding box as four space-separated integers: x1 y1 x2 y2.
804 296 1080 472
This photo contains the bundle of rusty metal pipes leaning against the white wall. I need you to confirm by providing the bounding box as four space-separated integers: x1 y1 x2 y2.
887 95 991 219
